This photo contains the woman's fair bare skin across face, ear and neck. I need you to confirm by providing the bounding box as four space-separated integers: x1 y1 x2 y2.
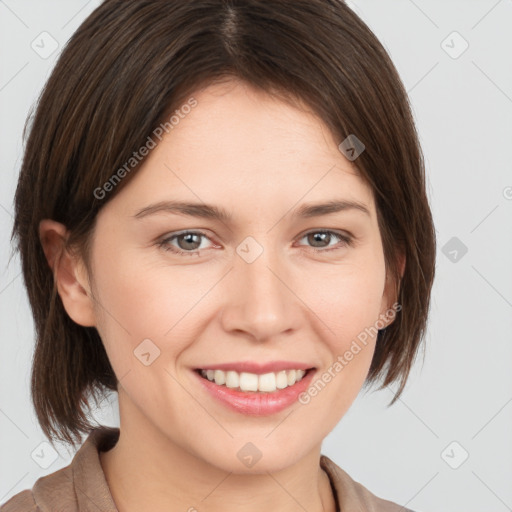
40 81 403 512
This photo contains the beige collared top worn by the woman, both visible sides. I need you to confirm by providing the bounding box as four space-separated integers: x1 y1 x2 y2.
0 426 412 512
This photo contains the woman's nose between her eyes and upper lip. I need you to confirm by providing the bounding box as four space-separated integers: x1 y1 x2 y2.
222 240 305 341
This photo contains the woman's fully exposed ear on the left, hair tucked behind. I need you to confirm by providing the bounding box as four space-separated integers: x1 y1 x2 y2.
39 219 96 327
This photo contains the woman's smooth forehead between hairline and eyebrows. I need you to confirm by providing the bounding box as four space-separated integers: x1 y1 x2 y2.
102 81 373 219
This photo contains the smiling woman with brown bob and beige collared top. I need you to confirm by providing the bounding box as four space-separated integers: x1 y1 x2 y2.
4 0 435 512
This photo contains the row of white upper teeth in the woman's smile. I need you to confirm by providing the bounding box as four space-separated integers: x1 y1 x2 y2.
201 370 306 392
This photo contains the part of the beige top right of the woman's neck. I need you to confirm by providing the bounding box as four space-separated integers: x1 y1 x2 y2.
320 455 414 512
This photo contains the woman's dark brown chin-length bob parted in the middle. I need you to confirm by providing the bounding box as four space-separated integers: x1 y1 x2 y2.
11 0 436 445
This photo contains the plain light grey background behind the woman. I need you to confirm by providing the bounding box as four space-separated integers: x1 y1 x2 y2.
0 0 512 512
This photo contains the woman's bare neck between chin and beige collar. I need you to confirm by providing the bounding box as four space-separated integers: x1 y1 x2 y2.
100 412 336 512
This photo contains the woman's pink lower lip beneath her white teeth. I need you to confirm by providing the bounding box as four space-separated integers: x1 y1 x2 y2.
194 369 316 416
